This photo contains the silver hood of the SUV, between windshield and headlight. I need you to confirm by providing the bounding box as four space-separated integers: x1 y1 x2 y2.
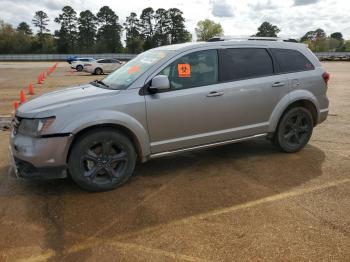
16 84 120 118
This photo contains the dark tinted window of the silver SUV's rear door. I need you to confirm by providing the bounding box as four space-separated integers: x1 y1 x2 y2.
219 48 273 82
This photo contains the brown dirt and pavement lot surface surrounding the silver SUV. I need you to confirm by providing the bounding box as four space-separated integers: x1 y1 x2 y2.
0 62 350 261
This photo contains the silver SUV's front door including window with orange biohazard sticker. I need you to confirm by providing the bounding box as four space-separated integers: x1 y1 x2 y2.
146 50 224 154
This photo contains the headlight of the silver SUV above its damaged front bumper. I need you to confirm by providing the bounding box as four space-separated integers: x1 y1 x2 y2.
18 117 55 137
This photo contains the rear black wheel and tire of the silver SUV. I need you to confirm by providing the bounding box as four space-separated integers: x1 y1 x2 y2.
272 107 314 153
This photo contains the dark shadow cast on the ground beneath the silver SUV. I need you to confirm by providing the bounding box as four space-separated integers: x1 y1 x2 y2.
0 139 325 257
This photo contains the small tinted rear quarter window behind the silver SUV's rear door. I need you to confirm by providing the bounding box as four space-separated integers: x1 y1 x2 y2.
271 48 314 73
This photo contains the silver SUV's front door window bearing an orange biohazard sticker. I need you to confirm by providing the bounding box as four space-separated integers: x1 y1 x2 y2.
159 50 218 90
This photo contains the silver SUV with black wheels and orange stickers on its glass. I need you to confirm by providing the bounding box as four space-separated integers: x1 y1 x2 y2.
10 39 329 191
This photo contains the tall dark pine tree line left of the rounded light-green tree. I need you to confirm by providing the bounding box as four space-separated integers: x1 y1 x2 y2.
0 6 192 53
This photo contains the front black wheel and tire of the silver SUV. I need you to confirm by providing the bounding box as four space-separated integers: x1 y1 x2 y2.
68 128 136 192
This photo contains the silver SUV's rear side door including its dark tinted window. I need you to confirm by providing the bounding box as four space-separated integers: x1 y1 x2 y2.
219 48 289 138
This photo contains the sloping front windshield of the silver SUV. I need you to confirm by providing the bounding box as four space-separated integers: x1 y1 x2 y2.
103 50 169 89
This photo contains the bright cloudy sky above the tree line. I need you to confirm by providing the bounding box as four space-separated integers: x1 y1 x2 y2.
0 0 350 39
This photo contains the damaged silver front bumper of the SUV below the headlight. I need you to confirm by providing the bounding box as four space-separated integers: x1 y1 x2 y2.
9 132 72 179
